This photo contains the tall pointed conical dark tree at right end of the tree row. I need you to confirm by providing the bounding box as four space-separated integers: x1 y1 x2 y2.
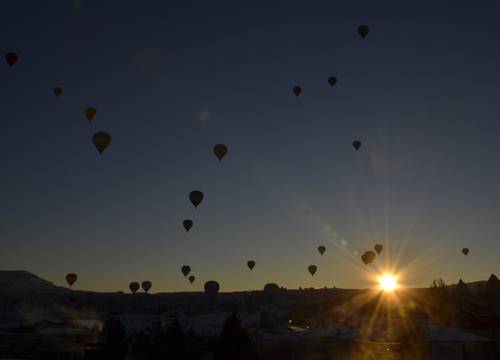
215 309 257 360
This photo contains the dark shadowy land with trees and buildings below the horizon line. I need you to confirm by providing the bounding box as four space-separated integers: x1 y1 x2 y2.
0 271 500 359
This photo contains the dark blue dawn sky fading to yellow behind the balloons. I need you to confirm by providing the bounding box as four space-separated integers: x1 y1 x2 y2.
0 0 500 291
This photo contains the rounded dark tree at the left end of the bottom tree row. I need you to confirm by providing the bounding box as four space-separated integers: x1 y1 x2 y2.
101 318 128 360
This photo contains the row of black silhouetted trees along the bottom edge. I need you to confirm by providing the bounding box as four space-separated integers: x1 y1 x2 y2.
99 310 257 360
